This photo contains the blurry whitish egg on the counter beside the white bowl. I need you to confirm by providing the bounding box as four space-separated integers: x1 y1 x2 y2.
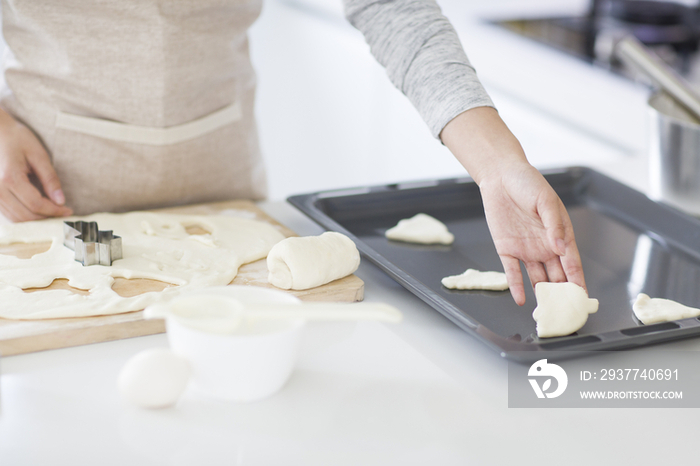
117 348 192 408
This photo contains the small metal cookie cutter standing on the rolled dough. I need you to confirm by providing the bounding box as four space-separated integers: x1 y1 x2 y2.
63 220 122 265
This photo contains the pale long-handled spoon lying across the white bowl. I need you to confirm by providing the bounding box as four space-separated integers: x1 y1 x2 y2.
144 296 403 334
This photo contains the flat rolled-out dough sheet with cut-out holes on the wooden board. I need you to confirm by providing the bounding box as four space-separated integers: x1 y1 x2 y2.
0 212 284 319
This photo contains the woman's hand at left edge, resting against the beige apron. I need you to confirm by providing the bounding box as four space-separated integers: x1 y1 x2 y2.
0 109 73 222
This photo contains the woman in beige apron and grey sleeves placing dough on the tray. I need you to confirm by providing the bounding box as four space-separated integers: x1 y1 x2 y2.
0 0 584 304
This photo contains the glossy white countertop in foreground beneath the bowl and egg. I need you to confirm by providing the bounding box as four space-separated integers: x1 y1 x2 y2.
0 202 700 466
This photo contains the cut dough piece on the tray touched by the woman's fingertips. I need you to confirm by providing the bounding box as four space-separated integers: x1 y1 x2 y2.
532 282 598 338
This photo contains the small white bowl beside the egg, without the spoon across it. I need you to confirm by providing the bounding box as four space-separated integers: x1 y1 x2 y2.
166 286 304 401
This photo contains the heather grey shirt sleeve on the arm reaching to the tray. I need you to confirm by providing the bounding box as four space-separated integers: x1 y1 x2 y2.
343 0 494 137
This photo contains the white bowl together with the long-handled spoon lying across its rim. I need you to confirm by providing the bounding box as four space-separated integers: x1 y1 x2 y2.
145 286 401 401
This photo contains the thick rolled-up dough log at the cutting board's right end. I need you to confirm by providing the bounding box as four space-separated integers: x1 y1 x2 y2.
267 231 360 290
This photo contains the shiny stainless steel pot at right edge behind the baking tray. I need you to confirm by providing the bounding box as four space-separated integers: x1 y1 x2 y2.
649 92 700 216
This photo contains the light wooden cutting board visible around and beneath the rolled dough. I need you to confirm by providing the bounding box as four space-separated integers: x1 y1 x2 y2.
0 201 364 356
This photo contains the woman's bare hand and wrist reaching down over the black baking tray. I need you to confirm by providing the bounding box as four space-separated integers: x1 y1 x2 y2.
441 107 586 306
